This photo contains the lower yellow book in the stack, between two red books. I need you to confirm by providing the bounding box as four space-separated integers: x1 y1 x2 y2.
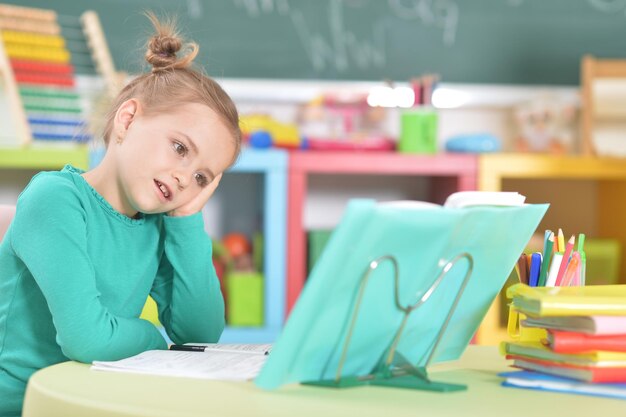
500 342 626 367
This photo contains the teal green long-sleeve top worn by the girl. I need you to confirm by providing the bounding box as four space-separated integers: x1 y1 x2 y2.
0 166 224 416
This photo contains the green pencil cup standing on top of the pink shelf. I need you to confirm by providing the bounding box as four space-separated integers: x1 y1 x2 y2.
398 109 438 154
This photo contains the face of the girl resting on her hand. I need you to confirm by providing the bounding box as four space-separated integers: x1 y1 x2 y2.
110 103 235 217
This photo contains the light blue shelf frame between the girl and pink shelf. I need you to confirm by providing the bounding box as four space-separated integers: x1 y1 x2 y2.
220 148 289 343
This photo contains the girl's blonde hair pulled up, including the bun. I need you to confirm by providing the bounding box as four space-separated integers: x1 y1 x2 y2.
103 12 241 164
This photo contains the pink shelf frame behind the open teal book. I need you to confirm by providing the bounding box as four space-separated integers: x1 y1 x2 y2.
286 151 478 313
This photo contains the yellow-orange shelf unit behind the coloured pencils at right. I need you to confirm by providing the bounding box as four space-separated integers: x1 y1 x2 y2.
477 154 626 344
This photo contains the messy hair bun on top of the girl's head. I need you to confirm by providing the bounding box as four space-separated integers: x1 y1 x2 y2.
146 12 198 73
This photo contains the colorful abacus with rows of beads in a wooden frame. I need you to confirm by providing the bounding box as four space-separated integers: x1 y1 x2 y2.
0 4 119 144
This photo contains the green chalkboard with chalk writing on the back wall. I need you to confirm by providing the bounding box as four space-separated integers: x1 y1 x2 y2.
8 0 626 85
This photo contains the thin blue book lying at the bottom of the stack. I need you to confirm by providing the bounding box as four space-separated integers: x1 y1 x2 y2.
498 371 626 400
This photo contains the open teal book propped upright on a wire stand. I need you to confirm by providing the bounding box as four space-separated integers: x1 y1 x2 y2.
255 200 548 392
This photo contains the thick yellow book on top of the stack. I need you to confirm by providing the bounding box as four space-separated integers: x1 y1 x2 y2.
506 284 626 317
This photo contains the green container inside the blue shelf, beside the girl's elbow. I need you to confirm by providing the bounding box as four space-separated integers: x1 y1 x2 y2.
226 272 263 326
